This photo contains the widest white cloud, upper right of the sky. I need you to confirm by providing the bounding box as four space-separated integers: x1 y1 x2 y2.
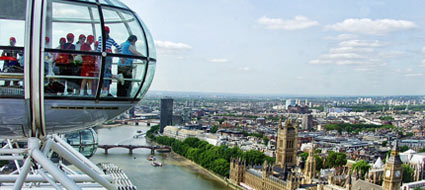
325 18 417 35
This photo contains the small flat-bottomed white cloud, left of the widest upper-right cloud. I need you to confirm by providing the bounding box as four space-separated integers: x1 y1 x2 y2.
257 16 319 30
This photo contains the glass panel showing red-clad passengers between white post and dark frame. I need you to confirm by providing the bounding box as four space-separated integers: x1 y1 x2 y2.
44 0 102 98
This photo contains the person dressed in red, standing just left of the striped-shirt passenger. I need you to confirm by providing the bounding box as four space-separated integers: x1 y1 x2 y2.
80 35 95 96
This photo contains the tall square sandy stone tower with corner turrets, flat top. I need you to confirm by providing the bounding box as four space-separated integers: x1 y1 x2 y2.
276 119 298 168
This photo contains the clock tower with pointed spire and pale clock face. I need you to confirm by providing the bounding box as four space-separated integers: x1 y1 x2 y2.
382 139 403 190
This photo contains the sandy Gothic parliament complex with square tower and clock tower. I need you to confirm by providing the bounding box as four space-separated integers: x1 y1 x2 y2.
229 119 403 190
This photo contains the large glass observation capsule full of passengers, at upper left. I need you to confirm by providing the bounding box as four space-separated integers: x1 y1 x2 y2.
0 0 156 138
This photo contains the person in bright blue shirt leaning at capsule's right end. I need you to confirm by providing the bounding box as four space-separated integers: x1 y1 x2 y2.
117 35 143 97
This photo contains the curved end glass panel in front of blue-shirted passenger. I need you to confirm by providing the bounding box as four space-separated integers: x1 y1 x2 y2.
99 7 147 99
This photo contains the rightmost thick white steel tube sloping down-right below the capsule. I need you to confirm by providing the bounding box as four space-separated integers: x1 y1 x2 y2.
52 143 117 190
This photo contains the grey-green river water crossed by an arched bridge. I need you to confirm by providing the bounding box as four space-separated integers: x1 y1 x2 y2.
90 126 227 190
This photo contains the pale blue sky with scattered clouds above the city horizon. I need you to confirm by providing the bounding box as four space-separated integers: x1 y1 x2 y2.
123 0 425 96
